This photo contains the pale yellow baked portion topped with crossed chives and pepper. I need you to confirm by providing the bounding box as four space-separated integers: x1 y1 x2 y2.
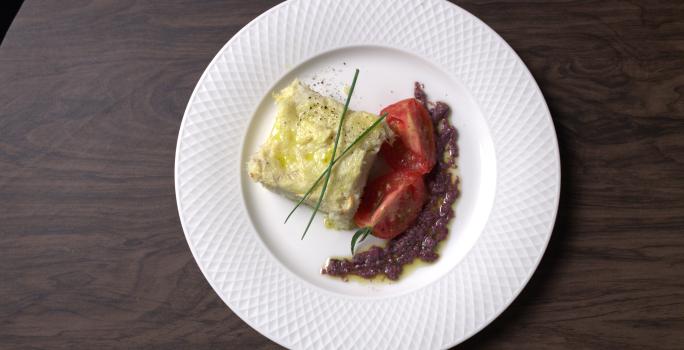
247 79 391 229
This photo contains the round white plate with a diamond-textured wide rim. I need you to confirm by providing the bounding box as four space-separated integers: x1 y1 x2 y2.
175 0 560 349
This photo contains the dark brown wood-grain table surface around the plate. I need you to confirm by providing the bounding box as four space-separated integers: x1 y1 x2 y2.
0 0 684 349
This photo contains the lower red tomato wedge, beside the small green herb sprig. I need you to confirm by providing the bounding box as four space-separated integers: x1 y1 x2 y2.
354 171 427 239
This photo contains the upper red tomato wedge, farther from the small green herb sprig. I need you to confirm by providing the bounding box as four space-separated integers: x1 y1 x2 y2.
380 98 436 174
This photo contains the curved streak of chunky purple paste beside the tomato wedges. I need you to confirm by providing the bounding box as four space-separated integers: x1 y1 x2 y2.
321 83 460 280
